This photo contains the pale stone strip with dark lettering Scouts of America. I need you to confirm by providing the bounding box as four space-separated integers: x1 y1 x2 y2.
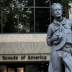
0 54 49 62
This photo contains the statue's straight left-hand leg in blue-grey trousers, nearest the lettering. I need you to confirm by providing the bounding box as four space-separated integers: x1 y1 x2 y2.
51 51 61 72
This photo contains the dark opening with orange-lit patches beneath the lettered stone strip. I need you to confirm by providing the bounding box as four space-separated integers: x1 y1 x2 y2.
0 62 48 72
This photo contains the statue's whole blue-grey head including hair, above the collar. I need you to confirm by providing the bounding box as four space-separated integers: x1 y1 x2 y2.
51 3 63 17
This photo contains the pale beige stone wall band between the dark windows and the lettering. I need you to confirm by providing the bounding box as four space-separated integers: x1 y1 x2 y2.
0 34 51 61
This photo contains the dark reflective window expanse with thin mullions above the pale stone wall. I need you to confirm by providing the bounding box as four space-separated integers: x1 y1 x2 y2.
0 0 68 33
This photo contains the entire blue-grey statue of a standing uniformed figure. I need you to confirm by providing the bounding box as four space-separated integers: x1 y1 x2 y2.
47 3 72 72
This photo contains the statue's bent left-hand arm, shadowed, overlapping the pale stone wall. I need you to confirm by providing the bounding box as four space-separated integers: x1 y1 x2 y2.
47 25 62 46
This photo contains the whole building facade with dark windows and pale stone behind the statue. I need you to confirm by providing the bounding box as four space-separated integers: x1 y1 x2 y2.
0 0 71 72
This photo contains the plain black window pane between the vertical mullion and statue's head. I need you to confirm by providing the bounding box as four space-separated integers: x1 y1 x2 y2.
35 8 50 32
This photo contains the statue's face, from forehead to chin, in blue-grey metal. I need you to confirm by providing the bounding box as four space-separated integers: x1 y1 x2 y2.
52 4 63 17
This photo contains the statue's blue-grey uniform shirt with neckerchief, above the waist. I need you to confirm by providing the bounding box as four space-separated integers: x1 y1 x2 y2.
47 18 72 50
